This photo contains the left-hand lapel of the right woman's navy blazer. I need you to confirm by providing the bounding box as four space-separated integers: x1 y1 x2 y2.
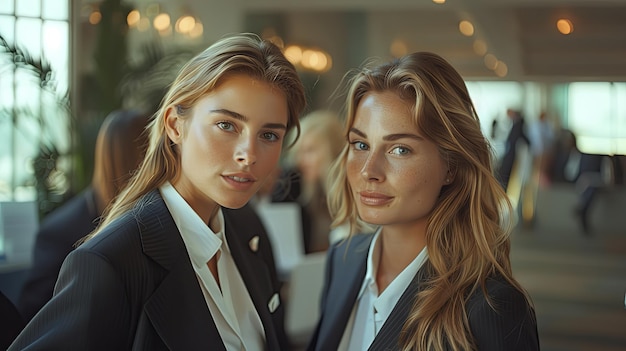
316 234 374 350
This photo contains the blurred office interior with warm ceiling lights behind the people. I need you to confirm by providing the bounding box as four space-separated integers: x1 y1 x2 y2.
0 0 626 351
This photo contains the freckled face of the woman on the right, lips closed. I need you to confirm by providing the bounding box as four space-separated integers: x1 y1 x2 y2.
346 91 448 232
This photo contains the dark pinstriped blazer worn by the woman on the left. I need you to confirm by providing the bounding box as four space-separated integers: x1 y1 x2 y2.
9 190 287 351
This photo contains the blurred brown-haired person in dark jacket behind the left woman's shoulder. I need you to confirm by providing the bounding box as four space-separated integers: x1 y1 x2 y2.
17 110 149 321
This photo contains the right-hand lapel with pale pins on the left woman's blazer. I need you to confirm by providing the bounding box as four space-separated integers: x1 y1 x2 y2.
218 209 281 350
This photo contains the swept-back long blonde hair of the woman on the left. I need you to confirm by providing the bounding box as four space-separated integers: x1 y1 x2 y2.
87 33 305 239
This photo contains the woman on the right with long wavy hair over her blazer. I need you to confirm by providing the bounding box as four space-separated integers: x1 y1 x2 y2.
309 52 539 351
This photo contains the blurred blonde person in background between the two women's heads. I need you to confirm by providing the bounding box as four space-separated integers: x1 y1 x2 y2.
287 110 347 253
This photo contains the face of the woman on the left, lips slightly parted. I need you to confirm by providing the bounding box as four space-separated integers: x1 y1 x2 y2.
166 74 289 219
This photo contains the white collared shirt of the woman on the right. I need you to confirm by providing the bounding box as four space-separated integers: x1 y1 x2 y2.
338 228 428 351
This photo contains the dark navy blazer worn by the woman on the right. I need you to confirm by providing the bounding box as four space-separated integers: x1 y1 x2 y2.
307 234 539 351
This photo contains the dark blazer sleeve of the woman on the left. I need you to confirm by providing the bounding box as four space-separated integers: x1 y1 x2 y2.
9 250 132 351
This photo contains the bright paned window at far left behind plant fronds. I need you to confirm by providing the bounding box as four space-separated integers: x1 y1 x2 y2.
0 0 71 206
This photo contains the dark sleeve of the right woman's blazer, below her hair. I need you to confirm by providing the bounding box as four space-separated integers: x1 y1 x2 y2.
467 280 539 351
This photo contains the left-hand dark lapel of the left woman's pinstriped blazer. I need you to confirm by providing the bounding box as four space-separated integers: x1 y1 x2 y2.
137 190 226 350
